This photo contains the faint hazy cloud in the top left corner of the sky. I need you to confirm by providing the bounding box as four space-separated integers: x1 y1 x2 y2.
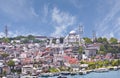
0 0 38 21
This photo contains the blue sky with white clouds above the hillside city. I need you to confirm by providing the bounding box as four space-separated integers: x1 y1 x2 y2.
0 0 120 39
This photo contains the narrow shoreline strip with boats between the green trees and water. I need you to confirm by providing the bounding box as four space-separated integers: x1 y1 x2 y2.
38 66 120 77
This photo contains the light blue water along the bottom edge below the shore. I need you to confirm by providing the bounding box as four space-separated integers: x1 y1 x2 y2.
40 70 120 78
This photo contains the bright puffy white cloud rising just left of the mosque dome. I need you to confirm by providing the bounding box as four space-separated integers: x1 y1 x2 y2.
51 7 76 36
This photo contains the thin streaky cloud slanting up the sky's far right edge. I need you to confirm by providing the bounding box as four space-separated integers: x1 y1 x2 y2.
96 0 120 38
